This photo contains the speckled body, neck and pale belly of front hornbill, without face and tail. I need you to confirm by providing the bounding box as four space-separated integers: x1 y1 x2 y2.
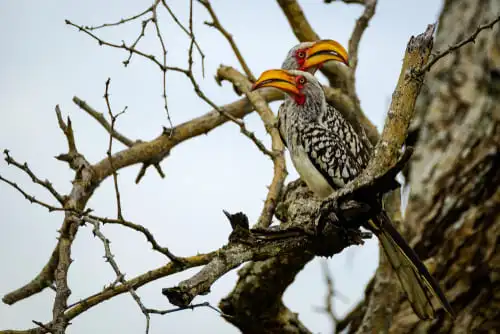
279 71 369 198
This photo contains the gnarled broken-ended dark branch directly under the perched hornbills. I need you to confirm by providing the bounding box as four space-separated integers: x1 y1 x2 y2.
163 160 411 307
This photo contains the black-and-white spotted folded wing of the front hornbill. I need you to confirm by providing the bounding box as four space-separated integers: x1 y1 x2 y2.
299 123 363 189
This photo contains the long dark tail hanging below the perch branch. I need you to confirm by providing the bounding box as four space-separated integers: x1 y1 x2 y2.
368 210 454 319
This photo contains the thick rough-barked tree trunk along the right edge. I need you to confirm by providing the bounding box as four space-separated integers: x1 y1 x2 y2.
356 0 500 333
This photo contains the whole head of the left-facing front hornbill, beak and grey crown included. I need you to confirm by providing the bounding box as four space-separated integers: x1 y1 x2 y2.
252 69 325 105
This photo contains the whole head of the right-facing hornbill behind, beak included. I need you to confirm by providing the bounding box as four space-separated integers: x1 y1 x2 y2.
281 39 349 74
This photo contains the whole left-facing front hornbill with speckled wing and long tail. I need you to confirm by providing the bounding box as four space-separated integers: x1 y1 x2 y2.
252 69 454 320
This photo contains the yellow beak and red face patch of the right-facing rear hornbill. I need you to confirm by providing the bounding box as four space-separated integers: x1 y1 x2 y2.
295 39 349 73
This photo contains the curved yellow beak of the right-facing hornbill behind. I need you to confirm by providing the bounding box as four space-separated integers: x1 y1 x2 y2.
303 39 349 69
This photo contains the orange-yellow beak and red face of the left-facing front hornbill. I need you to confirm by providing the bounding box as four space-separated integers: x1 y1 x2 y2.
252 70 307 105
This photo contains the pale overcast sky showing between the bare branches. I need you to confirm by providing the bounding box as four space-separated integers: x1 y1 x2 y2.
0 0 441 334
